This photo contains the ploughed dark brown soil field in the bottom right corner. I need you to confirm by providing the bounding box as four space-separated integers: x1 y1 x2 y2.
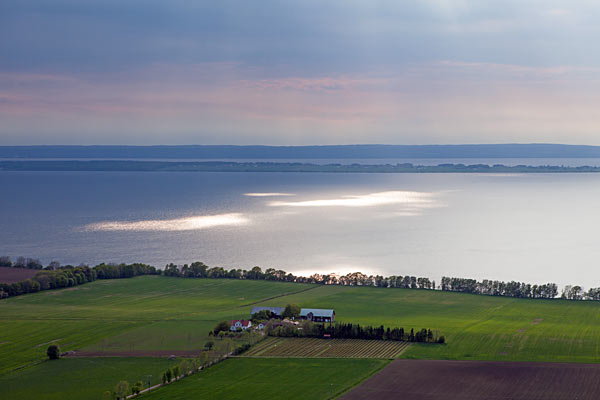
342 360 600 400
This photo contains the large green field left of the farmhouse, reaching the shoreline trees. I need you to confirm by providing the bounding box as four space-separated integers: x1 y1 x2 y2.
0 276 311 373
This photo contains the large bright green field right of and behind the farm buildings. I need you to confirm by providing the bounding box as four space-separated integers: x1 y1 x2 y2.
255 286 600 363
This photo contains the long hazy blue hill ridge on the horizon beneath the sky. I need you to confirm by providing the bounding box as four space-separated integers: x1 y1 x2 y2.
0 144 600 159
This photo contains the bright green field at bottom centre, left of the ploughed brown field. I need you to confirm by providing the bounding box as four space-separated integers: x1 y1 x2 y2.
142 358 388 400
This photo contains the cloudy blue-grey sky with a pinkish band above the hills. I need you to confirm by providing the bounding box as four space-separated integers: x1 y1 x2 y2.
0 0 600 145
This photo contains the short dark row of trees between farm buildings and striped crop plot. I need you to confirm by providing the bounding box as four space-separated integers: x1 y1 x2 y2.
266 321 445 343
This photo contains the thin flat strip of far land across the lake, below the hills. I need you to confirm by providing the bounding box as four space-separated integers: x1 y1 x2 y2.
0 160 600 173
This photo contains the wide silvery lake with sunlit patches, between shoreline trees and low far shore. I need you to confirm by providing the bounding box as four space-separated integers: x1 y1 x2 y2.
0 172 600 287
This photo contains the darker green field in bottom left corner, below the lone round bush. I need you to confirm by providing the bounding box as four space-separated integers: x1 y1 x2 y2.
0 357 177 400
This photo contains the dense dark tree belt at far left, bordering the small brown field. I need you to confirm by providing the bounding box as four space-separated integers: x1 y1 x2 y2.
0 264 160 299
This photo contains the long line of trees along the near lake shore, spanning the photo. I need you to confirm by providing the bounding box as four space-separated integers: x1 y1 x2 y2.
0 257 600 300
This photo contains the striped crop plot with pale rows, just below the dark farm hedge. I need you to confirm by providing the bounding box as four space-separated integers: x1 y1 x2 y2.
243 337 408 359
